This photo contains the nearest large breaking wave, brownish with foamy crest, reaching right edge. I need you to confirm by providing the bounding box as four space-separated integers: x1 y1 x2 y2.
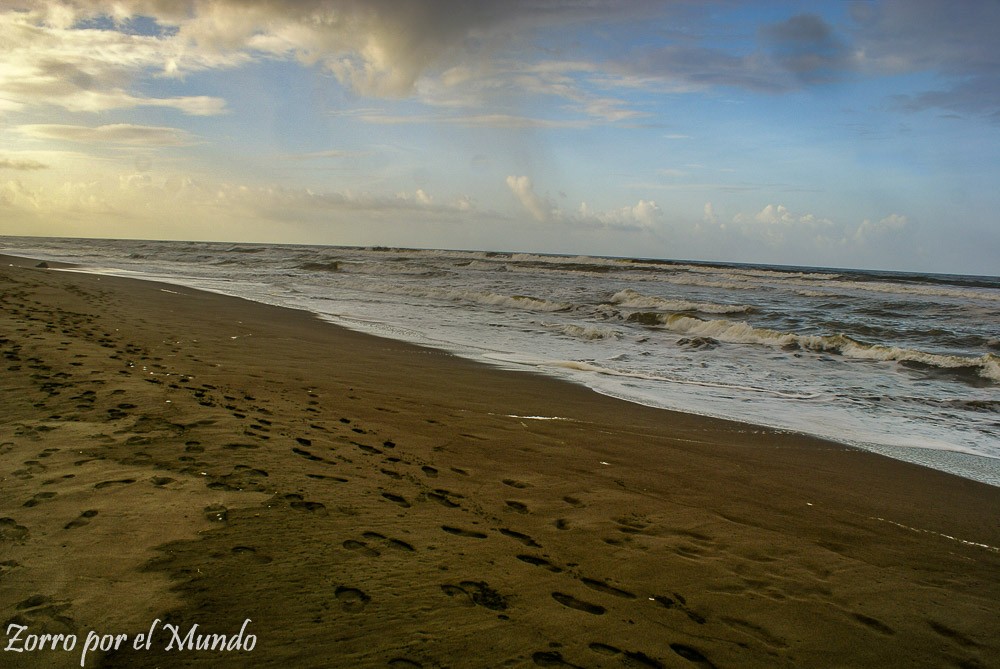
656 314 1000 383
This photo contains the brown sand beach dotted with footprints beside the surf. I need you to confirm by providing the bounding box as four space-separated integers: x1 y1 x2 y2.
0 253 1000 669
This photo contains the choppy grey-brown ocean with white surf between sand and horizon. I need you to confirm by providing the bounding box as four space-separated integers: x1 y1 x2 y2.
7 237 1000 486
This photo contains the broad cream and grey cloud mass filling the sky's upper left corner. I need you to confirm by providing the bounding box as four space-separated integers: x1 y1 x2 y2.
0 0 673 127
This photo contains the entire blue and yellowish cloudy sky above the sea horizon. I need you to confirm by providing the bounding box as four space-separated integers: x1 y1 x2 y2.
0 0 1000 275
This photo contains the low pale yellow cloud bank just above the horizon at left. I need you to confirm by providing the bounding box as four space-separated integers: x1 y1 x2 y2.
0 172 480 234
